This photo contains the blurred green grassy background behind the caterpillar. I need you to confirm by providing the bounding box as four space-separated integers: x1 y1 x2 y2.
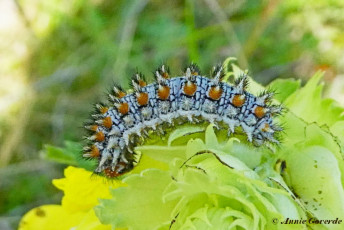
0 0 344 230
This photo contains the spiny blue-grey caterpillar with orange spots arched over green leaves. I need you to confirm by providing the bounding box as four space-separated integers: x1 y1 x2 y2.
83 64 282 178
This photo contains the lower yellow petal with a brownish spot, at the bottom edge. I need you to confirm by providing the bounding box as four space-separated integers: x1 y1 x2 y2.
18 205 85 230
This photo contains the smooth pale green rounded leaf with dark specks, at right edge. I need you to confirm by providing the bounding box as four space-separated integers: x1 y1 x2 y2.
286 146 344 225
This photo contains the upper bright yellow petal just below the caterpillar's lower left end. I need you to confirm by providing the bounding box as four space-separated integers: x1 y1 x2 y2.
53 166 124 211
